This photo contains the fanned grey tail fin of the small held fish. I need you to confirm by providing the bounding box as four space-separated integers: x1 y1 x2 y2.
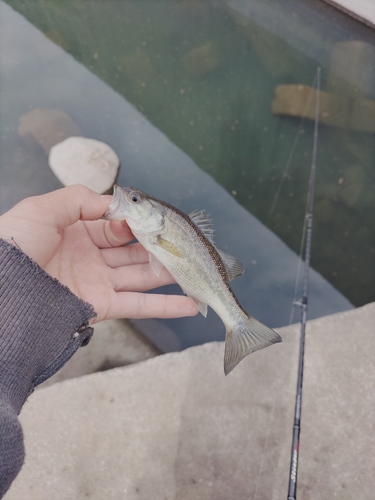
224 316 282 375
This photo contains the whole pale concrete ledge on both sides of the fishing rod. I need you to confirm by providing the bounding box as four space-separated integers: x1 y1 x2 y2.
5 303 375 500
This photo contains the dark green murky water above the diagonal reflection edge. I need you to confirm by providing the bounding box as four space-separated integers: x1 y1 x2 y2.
2 0 375 306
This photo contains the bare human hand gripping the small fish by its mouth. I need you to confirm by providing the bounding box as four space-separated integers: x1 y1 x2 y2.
0 185 198 323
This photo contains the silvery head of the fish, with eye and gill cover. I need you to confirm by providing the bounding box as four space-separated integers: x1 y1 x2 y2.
104 185 164 234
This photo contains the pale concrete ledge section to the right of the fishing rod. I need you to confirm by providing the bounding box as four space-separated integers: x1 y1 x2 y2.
299 303 375 500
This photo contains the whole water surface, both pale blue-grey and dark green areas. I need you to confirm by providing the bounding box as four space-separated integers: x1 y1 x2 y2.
0 0 375 352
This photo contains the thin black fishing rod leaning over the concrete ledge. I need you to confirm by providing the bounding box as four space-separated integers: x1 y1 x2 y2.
288 68 320 500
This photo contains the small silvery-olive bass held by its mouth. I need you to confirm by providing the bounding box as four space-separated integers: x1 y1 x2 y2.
104 185 282 375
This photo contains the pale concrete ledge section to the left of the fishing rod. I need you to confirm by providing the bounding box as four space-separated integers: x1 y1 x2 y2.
6 327 298 500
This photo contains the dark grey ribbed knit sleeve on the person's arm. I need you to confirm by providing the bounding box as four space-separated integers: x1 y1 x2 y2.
0 239 96 498
